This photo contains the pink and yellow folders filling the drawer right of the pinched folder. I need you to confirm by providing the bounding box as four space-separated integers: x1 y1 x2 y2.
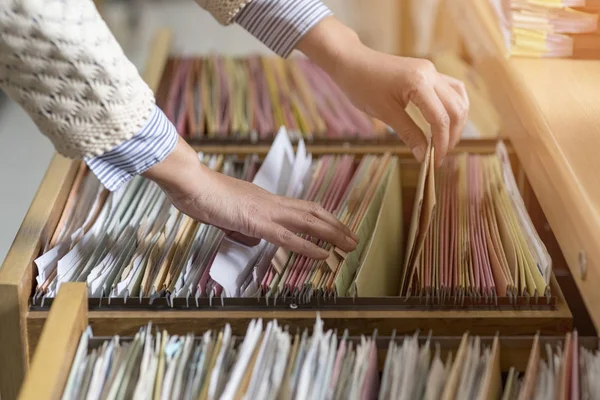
400 143 552 303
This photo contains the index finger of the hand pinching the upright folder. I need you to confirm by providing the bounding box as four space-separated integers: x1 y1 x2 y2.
411 86 450 166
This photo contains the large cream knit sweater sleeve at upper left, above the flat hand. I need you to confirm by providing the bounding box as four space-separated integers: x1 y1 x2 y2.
0 0 154 158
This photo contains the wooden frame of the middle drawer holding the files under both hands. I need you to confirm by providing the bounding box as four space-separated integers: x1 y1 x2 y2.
0 31 572 399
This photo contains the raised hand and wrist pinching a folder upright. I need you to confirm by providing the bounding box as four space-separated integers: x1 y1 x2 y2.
297 17 469 165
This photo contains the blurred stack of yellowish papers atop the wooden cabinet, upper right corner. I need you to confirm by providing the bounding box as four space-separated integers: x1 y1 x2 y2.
491 0 600 58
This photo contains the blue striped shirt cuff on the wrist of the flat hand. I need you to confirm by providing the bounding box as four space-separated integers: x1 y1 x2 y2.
85 106 179 191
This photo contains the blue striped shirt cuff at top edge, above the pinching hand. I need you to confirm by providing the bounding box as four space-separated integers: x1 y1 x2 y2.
235 0 331 58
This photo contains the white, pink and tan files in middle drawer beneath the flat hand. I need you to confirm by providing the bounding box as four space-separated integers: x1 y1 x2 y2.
34 129 402 304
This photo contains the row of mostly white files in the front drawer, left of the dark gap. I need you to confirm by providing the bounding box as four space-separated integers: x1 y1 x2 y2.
63 318 510 400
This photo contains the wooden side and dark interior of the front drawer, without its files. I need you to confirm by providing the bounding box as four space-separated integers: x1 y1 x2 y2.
16 283 598 399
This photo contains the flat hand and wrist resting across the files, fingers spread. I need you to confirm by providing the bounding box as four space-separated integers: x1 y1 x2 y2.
144 138 358 259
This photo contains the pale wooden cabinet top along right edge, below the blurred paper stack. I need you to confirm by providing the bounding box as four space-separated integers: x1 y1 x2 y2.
505 58 600 328
